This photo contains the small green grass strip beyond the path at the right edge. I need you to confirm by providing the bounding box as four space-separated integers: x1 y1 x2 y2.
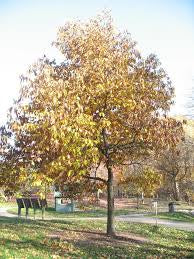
152 211 194 223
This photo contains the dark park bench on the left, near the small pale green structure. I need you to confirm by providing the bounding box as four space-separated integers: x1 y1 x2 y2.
16 198 47 219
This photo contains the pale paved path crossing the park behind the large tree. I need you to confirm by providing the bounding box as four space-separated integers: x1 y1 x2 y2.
0 208 194 231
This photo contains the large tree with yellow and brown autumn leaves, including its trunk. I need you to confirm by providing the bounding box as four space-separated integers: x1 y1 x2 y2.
4 14 182 238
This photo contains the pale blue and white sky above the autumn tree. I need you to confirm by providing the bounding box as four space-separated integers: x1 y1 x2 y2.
0 0 194 124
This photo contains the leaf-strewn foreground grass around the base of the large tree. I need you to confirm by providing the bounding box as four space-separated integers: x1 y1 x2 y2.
0 217 194 259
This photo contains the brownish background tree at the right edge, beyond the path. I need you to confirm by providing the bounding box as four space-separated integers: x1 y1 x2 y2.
157 138 194 201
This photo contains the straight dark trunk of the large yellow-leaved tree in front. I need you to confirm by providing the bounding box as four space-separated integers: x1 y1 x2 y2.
107 167 115 236
